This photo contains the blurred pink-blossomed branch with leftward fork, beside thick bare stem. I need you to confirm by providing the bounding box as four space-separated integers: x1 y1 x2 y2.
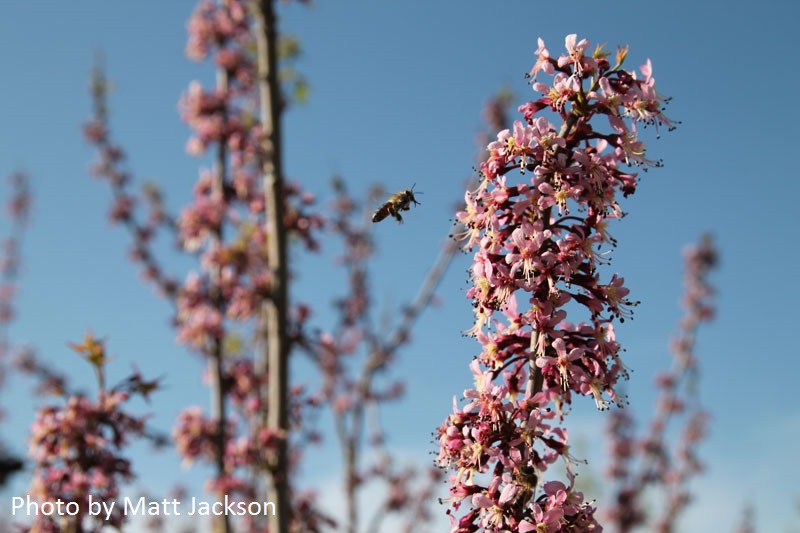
87 0 322 530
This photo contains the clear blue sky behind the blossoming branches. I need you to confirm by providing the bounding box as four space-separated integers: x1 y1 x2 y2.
0 0 800 533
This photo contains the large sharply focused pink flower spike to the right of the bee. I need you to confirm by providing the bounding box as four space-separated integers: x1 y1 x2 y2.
438 35 673 532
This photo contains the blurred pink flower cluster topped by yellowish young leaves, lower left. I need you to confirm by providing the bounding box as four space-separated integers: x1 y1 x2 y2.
23 334 158 532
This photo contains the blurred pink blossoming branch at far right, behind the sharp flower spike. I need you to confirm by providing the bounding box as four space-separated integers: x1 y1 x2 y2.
607 235 717 533
